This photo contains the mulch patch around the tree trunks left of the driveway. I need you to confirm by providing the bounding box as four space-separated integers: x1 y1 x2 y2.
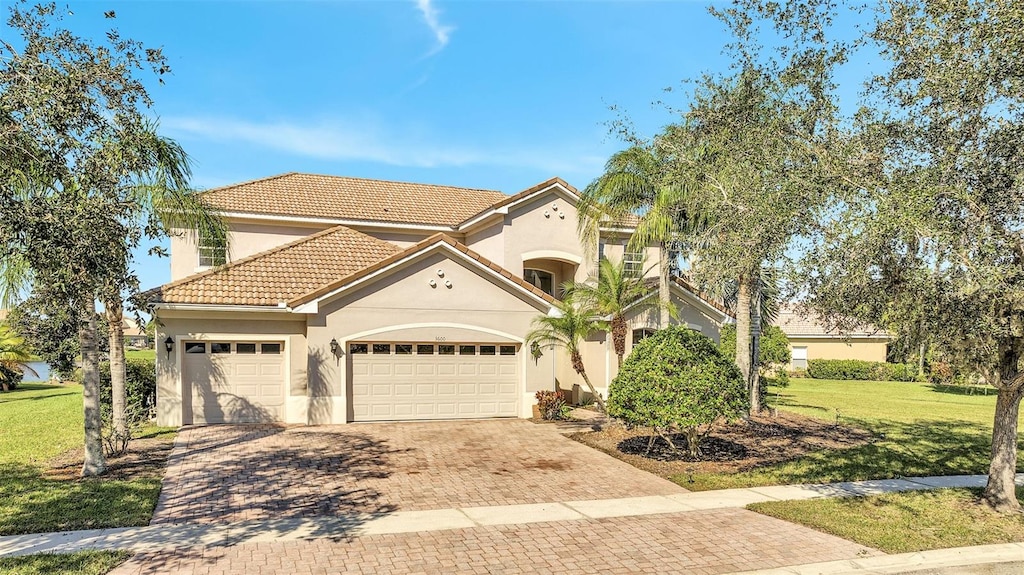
44 434 174 481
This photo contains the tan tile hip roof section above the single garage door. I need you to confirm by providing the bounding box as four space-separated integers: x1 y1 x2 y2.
143 226 400 306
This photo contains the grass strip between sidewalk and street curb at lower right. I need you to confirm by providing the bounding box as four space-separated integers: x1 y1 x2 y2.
748 489 1024 554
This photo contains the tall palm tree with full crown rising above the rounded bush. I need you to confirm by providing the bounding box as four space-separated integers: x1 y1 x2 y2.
578 144 699 327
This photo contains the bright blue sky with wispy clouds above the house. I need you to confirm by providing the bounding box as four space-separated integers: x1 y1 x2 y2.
14 0 864 288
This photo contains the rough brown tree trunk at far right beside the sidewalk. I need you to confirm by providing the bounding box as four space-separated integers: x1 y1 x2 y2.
981 385 1024 513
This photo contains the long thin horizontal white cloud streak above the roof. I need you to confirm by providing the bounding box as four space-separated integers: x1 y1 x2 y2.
161 117 604 175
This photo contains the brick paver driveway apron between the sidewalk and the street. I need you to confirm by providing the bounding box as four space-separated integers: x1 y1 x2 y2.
111 510 878 575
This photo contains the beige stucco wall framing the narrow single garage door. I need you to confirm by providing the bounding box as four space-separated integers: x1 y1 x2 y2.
156 309 307 427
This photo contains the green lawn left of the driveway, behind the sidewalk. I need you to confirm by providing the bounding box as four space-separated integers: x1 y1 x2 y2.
0 384 173 535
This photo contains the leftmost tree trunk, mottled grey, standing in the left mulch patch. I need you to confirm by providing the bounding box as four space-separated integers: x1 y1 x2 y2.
78 297 106 477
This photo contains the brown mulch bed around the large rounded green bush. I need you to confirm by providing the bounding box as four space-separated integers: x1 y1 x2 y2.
568 412 872 478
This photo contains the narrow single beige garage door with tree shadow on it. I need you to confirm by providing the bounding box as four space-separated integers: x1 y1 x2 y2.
182 341 285 424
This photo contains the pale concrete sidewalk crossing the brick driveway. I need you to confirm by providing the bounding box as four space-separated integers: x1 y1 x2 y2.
0 474 1024 557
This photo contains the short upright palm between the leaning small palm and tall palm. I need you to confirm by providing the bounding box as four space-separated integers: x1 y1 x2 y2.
566 258 650 367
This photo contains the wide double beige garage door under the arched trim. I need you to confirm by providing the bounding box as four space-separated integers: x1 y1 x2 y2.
348 342 519 422
